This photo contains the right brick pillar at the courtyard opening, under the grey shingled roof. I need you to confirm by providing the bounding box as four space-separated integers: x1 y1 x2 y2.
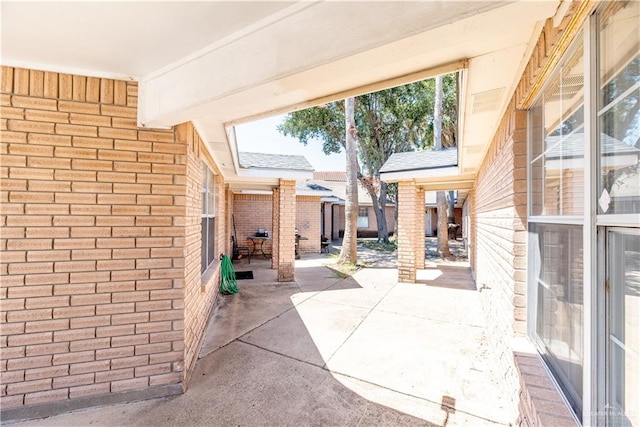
398 181 424 283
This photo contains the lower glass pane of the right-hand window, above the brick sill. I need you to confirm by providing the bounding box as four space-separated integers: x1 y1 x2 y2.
529 224 583 416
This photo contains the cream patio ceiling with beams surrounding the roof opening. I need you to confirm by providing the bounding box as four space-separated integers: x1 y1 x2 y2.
1 0 562 188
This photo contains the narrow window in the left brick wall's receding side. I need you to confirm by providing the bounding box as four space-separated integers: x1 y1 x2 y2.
200 162 216 273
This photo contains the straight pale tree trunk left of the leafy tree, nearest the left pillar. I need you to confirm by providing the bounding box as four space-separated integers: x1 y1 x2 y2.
338 98 358 264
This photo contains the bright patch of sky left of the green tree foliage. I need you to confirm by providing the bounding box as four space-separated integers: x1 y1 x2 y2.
236 115 345 171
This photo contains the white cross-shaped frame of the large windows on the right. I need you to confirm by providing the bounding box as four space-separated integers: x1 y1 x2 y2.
527 3 640 425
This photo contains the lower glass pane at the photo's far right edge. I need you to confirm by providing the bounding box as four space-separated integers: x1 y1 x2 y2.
607 231 640 426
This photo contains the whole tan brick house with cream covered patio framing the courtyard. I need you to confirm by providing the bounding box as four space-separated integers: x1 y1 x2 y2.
0 0 640 425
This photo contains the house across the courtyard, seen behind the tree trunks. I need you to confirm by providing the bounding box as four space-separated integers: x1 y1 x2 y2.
310 171 396 240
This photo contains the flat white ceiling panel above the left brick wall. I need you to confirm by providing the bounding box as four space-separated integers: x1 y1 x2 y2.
0 0 294 79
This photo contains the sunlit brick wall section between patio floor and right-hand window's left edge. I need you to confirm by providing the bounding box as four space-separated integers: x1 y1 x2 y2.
470 103 527 419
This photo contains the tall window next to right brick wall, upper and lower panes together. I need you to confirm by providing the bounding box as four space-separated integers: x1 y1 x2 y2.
528 25 588 417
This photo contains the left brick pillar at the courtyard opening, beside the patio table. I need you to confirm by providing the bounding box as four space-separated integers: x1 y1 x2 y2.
274 179 296 282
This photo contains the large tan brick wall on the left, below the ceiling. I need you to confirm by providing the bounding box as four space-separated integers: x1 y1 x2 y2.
0 67 220 415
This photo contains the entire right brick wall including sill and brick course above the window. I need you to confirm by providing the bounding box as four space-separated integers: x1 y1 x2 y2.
468 2 591 425
